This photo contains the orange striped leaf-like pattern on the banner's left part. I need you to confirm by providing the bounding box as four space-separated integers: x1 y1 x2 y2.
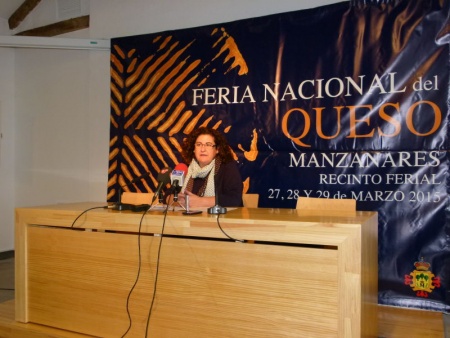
107 28 257 200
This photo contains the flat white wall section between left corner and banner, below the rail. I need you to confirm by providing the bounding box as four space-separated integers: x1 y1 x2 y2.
15 49 109 206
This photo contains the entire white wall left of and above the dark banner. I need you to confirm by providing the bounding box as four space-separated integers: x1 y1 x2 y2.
0 0 337 252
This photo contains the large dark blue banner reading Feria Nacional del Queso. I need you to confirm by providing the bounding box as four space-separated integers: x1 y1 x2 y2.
108 0 450 312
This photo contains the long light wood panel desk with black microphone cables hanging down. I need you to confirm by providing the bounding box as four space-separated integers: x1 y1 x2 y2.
15 203 378 338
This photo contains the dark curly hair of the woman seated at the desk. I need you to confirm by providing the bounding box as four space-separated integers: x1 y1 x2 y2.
181 127 234 163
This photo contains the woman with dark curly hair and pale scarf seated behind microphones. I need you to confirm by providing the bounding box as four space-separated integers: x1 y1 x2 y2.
178 127 243 208
